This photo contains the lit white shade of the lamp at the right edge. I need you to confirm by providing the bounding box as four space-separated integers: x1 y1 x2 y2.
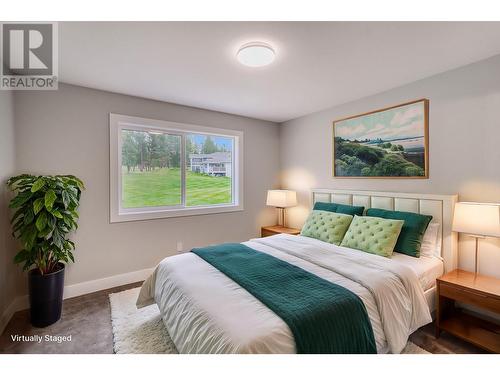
453 202 500 237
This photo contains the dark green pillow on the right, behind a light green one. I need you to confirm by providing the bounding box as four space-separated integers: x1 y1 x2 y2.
366 208 432 258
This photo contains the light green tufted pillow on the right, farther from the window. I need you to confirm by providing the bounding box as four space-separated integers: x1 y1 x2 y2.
341 216 404 257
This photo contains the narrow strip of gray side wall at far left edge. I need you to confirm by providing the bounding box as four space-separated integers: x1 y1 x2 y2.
0 91 19 330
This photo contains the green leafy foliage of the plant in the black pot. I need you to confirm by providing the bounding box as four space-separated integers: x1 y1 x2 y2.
7 174 84 275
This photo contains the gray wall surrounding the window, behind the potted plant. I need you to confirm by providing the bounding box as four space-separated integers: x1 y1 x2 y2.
15 84 279 285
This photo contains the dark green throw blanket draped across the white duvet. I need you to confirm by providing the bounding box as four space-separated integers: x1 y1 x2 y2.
192 243 376 353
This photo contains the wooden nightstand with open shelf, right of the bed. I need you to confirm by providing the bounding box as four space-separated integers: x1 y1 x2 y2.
436 270 500 353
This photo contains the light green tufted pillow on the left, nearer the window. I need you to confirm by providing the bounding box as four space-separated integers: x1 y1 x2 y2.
300 211 352 245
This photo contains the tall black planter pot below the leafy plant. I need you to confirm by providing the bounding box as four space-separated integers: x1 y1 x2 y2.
28 263 64 327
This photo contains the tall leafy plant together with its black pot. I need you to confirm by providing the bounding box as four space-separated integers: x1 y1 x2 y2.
7 174 84 327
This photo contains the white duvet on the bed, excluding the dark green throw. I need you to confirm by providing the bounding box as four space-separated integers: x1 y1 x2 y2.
137 234 432 353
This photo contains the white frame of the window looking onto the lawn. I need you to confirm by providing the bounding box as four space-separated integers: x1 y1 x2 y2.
109 113 243 223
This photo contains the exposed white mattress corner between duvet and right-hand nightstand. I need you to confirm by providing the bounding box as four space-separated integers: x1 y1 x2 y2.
391 253 444 291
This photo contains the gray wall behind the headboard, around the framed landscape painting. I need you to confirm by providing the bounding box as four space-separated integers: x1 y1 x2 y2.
280 56 500 277
